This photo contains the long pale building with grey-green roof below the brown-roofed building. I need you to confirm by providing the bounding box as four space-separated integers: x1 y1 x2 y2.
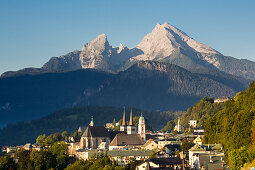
76 149 151 166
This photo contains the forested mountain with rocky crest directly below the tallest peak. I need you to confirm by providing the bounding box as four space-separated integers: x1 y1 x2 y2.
75 61 249 110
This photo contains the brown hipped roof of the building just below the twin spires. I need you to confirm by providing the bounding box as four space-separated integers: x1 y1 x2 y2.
110 133 144 146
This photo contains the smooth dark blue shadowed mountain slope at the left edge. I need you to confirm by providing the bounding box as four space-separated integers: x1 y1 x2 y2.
0 69 112 127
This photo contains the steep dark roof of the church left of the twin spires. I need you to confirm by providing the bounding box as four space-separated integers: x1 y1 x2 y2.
82 126 110 137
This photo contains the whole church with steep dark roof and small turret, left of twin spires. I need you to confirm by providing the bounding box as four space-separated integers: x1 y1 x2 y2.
80 118 110 149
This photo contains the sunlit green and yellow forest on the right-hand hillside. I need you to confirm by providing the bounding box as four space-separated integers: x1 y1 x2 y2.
204 82 255 169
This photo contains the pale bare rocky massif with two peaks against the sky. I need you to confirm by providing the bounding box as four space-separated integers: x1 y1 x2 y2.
2 23 255 80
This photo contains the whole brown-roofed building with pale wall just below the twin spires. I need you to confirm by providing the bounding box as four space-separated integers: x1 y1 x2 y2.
109 133 145 150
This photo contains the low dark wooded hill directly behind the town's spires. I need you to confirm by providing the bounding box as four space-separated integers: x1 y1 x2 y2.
0 106 181 145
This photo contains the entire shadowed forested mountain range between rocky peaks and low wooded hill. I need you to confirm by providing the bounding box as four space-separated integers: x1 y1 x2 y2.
0 61 249 125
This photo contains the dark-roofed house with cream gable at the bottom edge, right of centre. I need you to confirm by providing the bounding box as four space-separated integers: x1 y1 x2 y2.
136 157 183 170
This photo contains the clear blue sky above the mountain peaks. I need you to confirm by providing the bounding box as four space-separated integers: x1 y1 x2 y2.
0 0 255 74
